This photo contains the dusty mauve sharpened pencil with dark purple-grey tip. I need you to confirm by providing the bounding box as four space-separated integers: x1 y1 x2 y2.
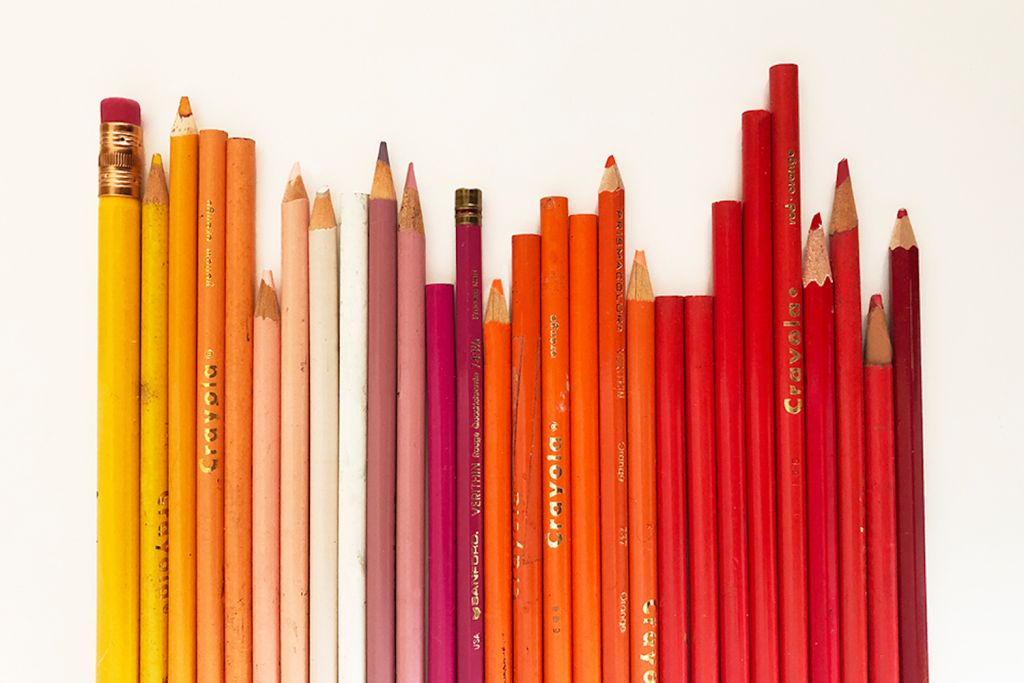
367 142 398 681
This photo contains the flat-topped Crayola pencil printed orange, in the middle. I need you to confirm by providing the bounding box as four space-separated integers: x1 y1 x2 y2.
541 197 572 681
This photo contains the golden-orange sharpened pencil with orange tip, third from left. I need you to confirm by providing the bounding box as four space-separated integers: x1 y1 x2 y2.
167 97 199 683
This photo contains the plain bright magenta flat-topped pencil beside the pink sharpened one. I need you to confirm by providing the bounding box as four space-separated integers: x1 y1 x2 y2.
426 285 456 683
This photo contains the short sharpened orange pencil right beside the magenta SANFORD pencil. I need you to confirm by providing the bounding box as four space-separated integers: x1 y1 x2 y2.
483 280 512 683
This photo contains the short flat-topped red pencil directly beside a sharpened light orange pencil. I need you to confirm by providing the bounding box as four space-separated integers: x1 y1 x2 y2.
654 296 690 683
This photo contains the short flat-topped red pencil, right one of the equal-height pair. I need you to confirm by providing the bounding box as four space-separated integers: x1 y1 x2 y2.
683 296 719 683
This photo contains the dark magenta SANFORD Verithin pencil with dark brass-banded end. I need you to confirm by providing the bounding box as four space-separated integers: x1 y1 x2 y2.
455 189 484 683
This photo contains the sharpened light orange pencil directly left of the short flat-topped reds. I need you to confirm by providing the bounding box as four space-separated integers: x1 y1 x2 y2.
626 251 659 683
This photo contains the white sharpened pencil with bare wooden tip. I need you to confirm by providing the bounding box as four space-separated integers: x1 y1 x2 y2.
308 187 339 681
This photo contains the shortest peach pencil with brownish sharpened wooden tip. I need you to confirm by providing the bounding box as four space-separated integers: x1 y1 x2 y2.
253 270 281 683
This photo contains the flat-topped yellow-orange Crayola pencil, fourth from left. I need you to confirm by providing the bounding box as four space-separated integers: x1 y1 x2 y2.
195 130 227 683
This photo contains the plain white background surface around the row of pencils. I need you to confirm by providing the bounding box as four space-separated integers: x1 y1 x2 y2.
0 0 1024 683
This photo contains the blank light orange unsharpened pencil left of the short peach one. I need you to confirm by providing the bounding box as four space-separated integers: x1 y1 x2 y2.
224 137 256 683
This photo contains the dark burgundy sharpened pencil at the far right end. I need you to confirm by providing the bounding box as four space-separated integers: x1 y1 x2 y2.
889 209 928 683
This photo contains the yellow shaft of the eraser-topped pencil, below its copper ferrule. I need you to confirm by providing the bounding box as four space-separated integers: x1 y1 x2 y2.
96 197 139 683
